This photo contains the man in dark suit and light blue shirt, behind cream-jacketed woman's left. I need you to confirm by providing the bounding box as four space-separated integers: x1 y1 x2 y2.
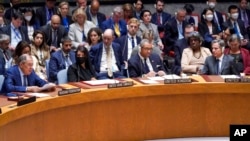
164 9 188 54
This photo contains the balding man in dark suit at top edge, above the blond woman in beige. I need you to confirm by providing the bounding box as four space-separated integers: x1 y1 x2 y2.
86 0 106 27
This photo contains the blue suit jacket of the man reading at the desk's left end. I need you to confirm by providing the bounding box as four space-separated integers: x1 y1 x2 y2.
3 65 47 93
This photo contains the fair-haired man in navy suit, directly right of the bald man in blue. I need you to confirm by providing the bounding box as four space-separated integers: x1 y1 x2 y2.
115 18 141 61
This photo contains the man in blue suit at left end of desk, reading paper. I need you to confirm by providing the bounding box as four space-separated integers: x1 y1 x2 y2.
3 54 54 93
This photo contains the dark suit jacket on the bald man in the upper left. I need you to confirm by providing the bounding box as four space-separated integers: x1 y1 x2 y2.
41 24 68 47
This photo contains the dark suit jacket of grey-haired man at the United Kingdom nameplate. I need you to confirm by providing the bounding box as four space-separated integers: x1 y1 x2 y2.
128 53 166 77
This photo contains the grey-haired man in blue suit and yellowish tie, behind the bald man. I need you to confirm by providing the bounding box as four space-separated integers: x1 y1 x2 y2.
101 6 127 38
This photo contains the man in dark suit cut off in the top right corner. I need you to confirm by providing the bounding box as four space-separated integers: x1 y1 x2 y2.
239 0 250 29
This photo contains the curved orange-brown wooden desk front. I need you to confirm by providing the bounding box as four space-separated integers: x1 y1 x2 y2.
0 83 250 141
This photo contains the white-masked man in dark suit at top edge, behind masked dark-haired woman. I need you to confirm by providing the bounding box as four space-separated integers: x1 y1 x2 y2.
206 0 224 32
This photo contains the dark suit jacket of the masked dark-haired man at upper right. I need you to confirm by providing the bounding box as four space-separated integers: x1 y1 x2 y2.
223 19 248 39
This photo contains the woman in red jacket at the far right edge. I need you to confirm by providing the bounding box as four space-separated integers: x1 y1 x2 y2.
224 34 250 74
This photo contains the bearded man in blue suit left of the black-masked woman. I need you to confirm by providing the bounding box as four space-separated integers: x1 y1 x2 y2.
49 37 76 82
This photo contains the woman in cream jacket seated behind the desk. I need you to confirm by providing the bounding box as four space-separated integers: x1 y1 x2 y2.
181 31 211 74
